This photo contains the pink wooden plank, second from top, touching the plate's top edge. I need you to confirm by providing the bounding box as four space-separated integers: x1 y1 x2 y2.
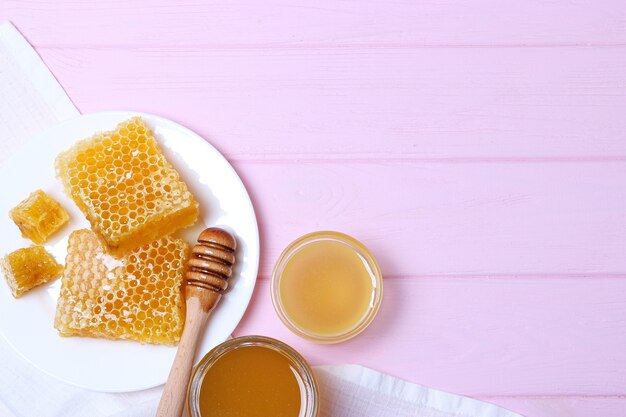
33 47 626 162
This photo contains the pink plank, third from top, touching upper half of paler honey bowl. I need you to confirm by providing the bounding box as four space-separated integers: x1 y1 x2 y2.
225 161 626 276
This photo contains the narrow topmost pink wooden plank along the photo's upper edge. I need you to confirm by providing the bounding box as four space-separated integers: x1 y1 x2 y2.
0 0 626 47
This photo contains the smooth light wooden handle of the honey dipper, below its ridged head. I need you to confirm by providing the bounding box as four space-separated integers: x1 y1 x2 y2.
156 293 217 417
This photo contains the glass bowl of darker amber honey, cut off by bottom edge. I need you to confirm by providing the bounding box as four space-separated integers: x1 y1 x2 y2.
187 336 319 417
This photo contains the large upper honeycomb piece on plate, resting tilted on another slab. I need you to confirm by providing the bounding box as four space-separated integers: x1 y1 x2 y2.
56 117 198 255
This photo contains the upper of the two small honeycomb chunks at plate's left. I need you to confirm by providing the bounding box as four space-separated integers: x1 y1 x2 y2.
9 190 70 245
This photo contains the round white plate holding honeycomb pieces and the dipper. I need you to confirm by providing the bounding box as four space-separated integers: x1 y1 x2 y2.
0 112 259 392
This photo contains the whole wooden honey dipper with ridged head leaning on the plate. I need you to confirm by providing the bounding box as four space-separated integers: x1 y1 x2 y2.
156 227 237 417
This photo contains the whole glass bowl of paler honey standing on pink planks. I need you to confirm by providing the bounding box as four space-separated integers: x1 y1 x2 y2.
271 231 383 343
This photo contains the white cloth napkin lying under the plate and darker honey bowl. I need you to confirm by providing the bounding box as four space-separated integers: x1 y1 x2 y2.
0 22 521 417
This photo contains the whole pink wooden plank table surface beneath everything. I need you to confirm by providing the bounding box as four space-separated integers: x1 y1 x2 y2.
0 0 626 417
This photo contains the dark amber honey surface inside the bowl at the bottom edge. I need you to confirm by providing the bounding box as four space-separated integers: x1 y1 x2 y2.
200 346 301 417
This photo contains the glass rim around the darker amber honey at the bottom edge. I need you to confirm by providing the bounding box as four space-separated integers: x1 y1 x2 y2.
187 335 319 417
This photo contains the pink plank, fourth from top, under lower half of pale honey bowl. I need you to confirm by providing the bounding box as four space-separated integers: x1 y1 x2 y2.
235 277 626 394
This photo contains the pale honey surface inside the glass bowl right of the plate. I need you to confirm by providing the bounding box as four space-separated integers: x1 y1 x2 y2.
279 240 374 336
